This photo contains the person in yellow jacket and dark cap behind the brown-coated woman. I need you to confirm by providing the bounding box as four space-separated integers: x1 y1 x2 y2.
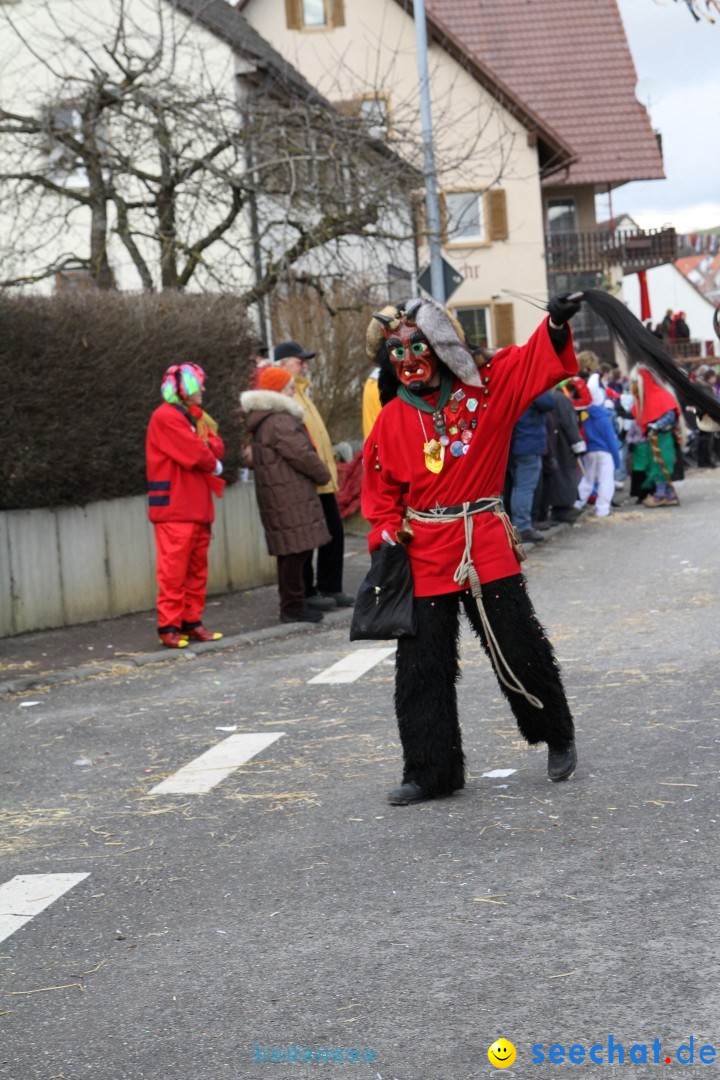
273 341 355 611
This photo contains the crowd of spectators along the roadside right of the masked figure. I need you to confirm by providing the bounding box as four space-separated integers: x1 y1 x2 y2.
505 352 720 542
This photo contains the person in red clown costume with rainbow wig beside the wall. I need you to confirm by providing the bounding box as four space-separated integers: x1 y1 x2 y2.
146 364 225 649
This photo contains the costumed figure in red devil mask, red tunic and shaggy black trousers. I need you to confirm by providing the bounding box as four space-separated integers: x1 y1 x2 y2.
363 294 579 806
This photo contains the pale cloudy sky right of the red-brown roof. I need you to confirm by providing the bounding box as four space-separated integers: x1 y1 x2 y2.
613 0 720 232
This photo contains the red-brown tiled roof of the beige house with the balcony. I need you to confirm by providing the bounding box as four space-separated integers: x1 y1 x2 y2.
423 0 665 186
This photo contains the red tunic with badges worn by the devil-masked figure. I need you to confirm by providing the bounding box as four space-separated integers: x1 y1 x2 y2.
363 321 578 596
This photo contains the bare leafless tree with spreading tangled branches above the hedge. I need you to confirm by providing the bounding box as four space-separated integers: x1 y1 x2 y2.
0 0 417 301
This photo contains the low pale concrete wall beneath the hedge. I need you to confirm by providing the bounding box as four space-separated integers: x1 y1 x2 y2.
0 483 276 637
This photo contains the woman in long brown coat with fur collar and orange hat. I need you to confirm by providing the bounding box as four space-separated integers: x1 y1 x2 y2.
240 367 330 622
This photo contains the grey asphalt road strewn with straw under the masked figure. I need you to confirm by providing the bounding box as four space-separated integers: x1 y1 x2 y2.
0 473 720 1080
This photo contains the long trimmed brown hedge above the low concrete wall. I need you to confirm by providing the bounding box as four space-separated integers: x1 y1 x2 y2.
0 293 254 510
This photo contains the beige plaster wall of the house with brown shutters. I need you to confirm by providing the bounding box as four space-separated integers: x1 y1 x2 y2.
243 0 547 343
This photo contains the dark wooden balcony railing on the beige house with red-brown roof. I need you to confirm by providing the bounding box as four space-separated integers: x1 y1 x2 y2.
545 229 677 273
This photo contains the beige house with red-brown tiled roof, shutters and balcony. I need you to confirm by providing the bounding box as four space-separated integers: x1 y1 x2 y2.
237 0 674 352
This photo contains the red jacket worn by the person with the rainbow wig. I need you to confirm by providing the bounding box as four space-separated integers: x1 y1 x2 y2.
146 402 225 523
